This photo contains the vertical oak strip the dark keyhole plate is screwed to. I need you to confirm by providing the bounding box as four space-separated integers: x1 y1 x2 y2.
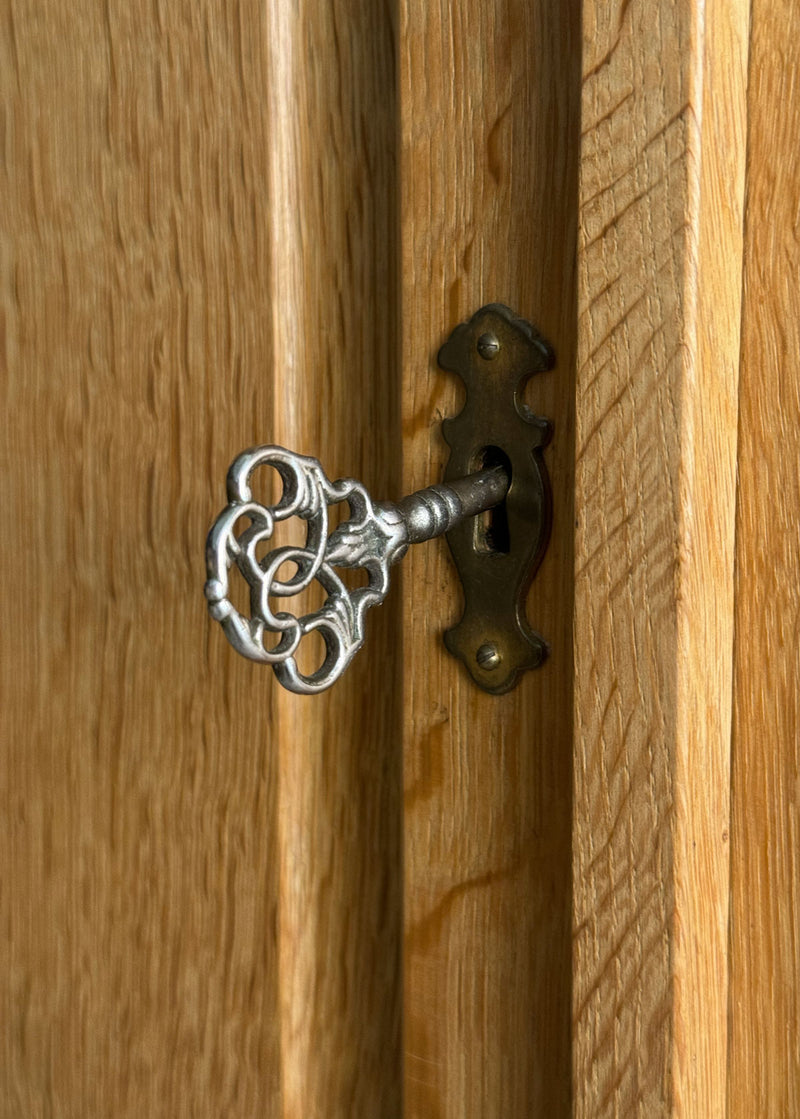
398 0 580 1119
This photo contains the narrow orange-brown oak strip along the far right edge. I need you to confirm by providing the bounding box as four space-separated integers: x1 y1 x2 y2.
730 0 800 1119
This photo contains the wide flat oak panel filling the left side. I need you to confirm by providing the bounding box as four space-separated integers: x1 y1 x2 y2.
0 3 280 1117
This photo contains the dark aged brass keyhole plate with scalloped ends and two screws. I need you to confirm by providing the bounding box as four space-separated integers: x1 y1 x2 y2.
439 303 555 695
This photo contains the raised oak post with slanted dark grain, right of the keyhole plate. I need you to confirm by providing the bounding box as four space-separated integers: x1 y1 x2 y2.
573 0 747 1117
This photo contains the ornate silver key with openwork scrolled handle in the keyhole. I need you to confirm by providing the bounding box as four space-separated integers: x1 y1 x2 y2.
205 445 509 695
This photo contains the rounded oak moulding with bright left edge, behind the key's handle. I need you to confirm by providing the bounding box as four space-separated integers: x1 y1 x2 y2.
270 0 403 1119
